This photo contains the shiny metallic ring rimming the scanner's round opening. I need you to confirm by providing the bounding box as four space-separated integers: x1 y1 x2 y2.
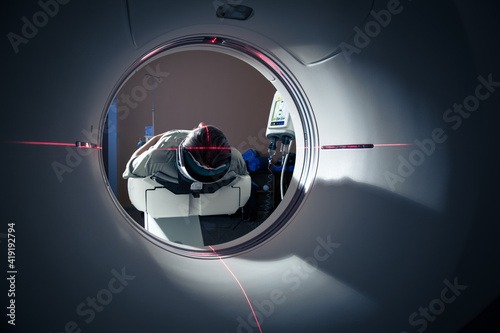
100 35 320 259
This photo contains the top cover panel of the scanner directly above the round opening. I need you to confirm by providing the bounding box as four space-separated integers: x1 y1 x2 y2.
129 0 372 63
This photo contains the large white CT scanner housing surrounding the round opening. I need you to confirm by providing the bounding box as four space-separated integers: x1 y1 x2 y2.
0 0 500 333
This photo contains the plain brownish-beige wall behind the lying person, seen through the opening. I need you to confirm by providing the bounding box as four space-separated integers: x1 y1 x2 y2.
113 51 275 206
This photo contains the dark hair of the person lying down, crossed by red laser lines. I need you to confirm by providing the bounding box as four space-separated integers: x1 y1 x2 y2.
183 125 231 169
